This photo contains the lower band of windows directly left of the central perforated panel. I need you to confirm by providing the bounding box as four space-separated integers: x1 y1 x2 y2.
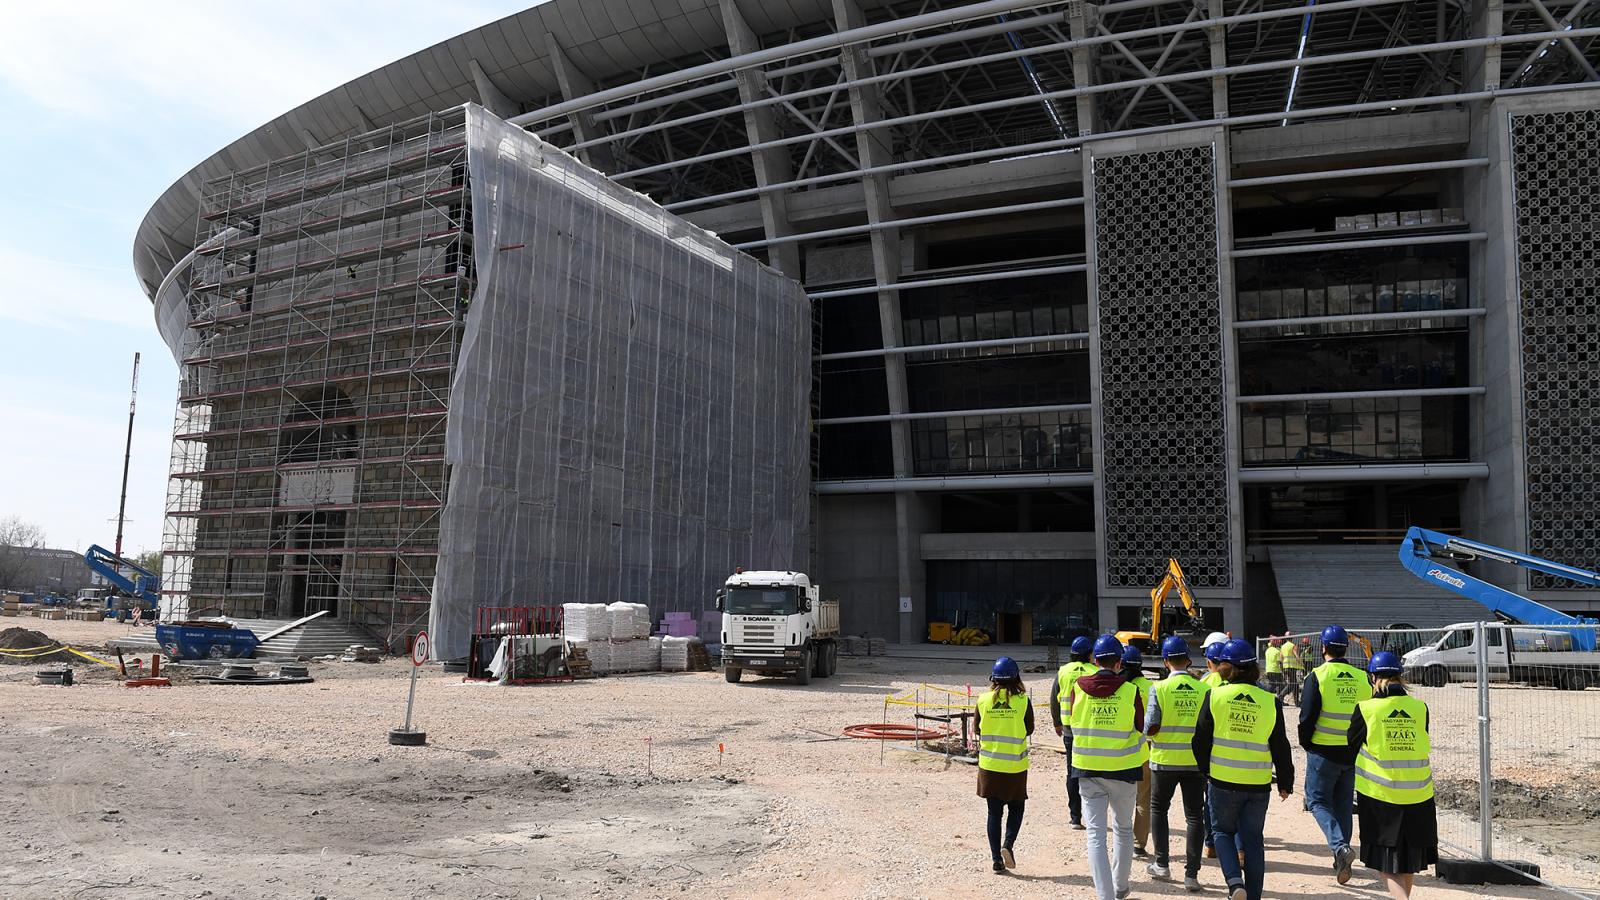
910 412 1094 476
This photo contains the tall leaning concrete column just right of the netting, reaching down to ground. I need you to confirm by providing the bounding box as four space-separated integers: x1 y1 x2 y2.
834 0 925 644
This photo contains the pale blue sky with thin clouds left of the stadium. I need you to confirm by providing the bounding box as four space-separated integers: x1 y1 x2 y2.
0 0 536 552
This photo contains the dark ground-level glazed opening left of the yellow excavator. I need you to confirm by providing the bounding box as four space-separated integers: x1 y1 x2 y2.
928 559 1099 645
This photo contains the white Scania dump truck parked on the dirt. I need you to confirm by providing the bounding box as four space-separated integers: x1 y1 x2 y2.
717 570 838 684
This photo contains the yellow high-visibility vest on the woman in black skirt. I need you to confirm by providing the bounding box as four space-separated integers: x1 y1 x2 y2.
1355 697 1434 804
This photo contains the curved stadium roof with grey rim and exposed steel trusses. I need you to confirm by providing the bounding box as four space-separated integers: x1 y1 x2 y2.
133 0 1600 296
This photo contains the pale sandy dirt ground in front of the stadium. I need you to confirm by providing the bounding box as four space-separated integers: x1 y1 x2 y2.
0 620 1600 900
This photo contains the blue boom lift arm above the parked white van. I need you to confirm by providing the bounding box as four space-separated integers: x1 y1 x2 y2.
1400 525 1600 650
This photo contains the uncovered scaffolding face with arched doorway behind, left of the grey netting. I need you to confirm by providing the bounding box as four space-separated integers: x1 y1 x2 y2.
163 109 475 645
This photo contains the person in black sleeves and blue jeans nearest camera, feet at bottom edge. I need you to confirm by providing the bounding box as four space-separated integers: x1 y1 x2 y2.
1194 639 1294 900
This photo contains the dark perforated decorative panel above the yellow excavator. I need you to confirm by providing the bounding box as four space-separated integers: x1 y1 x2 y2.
1093 146 1234 588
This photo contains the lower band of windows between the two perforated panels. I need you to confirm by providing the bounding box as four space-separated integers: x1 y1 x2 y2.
1240 397 1469 466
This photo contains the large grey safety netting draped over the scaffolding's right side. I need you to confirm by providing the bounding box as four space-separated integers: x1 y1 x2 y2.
430 106 811 658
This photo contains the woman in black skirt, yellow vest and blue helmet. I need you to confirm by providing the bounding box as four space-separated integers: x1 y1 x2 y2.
1347 650 1438 900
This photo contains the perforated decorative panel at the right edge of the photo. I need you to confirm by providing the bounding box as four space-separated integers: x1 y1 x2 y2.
1510 109 1600 588
